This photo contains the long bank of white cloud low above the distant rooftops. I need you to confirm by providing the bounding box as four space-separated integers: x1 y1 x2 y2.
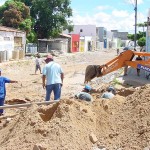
73 9 145 33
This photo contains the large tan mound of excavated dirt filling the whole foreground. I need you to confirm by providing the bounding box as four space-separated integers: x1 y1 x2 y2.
0 85 150 150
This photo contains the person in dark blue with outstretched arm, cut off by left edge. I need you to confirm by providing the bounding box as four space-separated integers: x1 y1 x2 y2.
0 69 18 116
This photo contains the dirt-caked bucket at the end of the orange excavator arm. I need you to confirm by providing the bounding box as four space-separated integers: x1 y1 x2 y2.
84 65 101 83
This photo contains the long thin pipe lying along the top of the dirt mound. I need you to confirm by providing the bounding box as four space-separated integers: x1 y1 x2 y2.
0 100 60 109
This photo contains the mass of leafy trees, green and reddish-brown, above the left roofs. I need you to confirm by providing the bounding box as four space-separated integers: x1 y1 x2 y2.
0 0 73 42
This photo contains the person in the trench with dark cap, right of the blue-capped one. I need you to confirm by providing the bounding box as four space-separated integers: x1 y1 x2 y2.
101 86 116 99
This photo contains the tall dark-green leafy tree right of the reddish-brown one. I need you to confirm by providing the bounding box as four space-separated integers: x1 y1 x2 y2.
30 0 72 38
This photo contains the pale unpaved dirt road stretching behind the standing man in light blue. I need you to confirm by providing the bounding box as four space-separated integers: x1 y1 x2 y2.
0 50 116 105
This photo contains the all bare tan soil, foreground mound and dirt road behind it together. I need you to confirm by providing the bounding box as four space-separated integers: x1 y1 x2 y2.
0 51 150 150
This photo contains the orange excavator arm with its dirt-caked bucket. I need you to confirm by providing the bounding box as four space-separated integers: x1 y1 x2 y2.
84 50 150 83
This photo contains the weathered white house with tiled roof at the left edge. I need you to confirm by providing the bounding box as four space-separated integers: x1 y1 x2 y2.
0 26 26 62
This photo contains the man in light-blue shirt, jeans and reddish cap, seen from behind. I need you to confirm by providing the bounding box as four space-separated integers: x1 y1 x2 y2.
42 54 64 101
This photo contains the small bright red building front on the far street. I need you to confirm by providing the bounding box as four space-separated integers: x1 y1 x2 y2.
71 34 80 52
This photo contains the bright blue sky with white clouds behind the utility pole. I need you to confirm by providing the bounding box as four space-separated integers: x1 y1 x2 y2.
0 0 150 33
